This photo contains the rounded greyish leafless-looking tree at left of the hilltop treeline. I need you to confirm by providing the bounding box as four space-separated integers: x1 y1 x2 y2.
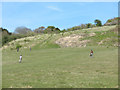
14 26 32 34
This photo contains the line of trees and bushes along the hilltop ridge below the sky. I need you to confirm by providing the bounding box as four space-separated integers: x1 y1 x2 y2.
0 19 112 45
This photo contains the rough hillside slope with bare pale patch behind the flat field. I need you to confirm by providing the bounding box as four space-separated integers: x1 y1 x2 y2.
3 25 118 50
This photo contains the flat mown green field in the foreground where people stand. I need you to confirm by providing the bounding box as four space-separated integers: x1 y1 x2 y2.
2 46 118 88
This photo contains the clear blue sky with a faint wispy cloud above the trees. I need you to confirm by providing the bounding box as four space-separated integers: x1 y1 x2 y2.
2 2 118 32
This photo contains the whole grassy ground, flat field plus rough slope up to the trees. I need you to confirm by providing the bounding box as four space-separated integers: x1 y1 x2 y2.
2 26 118 88
